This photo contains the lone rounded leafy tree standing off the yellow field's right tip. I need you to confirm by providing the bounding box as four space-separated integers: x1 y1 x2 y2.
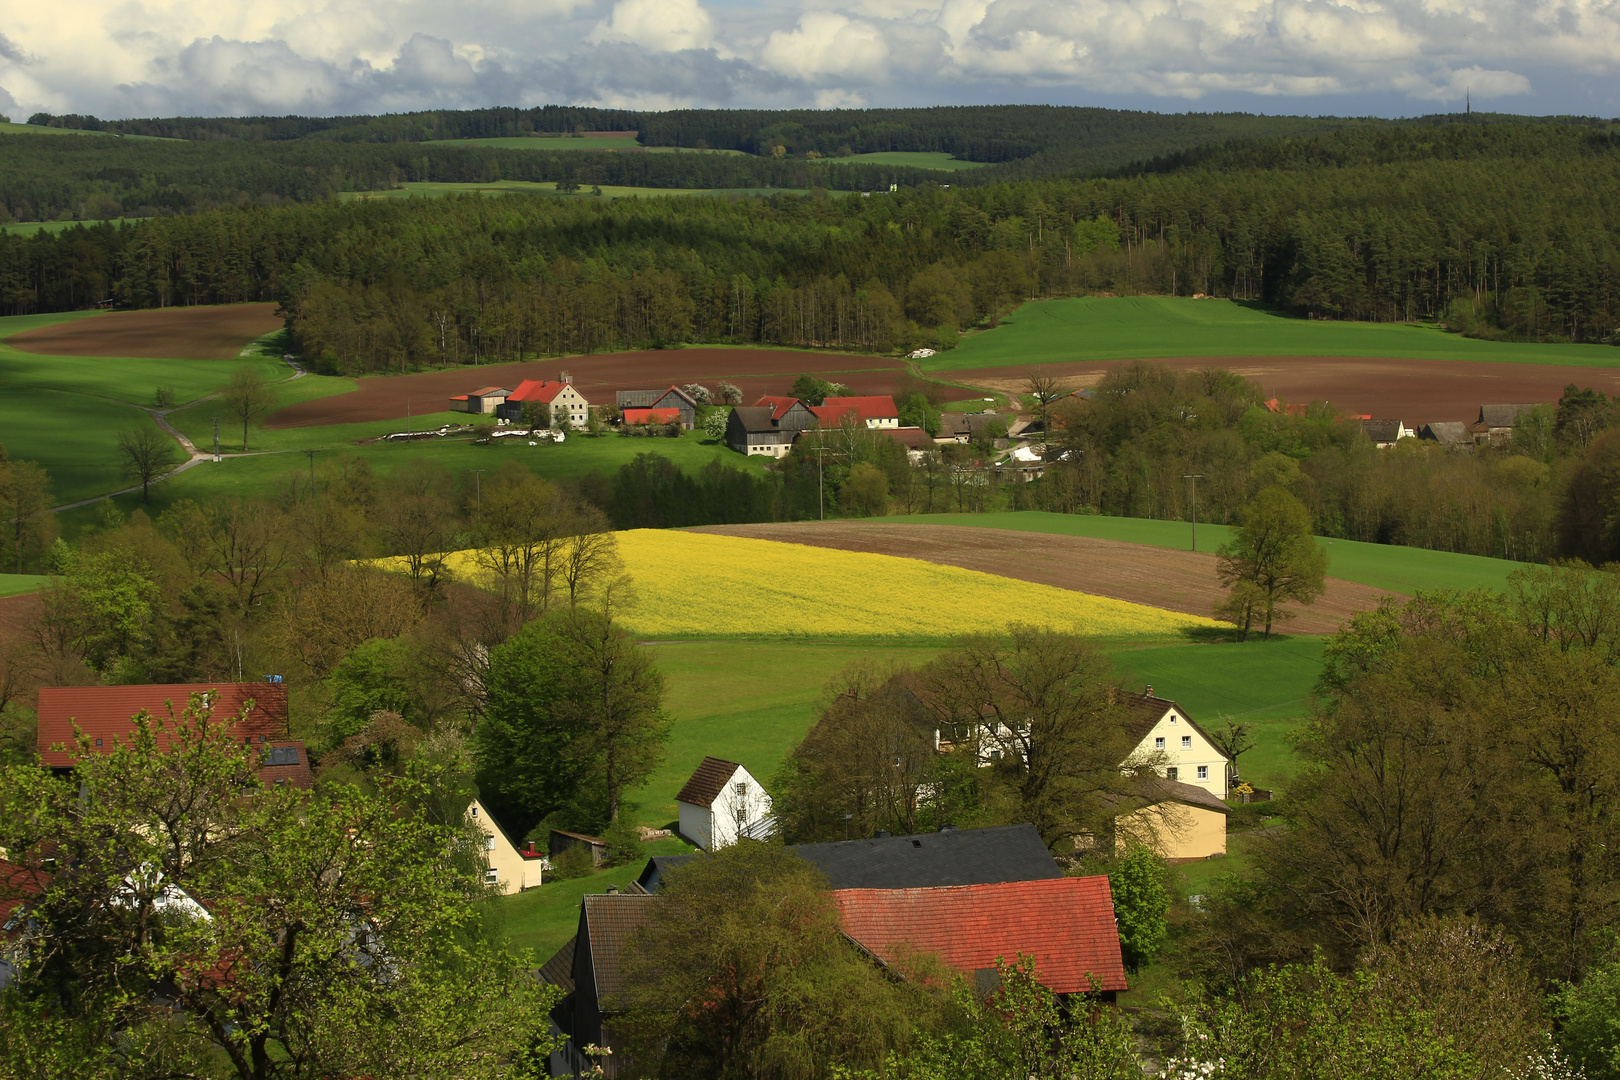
1217 487 1327 638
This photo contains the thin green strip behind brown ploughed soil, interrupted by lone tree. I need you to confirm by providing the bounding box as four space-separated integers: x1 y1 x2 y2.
886 510 1524 596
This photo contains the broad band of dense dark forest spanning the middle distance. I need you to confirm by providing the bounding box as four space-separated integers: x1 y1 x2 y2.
0 125 1620 354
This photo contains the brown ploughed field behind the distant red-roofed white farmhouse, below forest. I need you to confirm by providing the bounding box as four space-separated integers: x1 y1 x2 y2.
259 348 906 427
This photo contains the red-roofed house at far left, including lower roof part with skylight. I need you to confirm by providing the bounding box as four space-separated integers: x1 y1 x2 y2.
39 683 314 787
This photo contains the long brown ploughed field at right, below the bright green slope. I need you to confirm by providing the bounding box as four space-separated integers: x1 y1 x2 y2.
932 353 1620 426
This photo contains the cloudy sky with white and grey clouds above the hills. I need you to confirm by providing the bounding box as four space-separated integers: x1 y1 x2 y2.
0 0 1620 121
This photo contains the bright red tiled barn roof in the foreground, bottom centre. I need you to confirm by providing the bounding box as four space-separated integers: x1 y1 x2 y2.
833 876 1128 994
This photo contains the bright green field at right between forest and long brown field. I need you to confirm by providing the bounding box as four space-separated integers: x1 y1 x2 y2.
922 296 1620 372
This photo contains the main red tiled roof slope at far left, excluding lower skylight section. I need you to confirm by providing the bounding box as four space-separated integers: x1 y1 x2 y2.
39 683 289 771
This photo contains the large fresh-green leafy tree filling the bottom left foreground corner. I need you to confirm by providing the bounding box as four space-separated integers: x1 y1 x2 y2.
0 698 554 1080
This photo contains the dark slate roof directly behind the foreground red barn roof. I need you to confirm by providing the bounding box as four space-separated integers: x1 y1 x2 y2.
638 824 1063 892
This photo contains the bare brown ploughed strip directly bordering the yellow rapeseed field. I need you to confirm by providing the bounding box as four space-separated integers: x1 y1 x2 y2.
692 521 1390 633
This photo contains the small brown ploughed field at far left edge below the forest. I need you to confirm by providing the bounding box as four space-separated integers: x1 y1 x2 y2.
5 304 282 359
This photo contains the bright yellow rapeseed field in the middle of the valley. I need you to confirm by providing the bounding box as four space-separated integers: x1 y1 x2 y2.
417 529 1223 640
